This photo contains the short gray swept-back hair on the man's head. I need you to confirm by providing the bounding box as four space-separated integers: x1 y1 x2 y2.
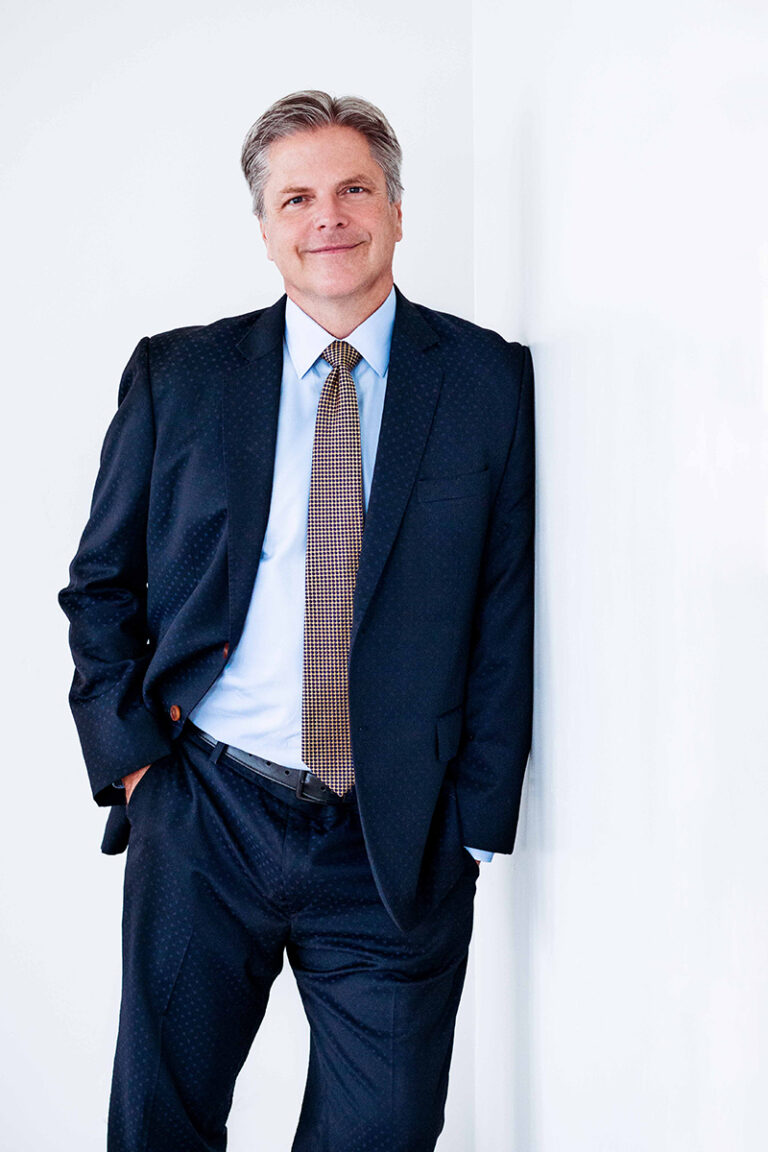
241 89 403 219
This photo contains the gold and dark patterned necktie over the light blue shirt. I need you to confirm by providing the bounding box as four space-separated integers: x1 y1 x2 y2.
302 340 364 796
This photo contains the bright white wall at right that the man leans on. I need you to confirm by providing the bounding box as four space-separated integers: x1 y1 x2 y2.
473 0 768 1152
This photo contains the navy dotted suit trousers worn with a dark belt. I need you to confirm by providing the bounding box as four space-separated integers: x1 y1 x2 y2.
107 734 479 1152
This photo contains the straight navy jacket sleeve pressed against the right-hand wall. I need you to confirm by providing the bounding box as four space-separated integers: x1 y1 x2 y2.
454 347 535 852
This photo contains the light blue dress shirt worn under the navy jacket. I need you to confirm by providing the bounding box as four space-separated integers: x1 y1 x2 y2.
190 287 493 861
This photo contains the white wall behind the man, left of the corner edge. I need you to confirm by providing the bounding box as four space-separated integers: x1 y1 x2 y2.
0 0 472 1152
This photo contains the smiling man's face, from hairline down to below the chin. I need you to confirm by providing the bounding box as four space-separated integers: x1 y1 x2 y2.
259 124 403 311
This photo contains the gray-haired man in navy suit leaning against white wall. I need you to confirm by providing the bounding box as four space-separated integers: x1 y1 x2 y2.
60 91 534 1152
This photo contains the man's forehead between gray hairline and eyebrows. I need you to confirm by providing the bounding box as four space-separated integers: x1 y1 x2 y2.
267 124 385 190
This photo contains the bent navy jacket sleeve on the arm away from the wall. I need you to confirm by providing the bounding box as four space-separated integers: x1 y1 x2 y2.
59 336 172 805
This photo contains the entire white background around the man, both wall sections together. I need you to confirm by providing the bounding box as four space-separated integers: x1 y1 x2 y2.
0 0 768 1152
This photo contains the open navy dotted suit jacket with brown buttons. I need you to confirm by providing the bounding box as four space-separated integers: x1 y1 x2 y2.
59 287 534 931
